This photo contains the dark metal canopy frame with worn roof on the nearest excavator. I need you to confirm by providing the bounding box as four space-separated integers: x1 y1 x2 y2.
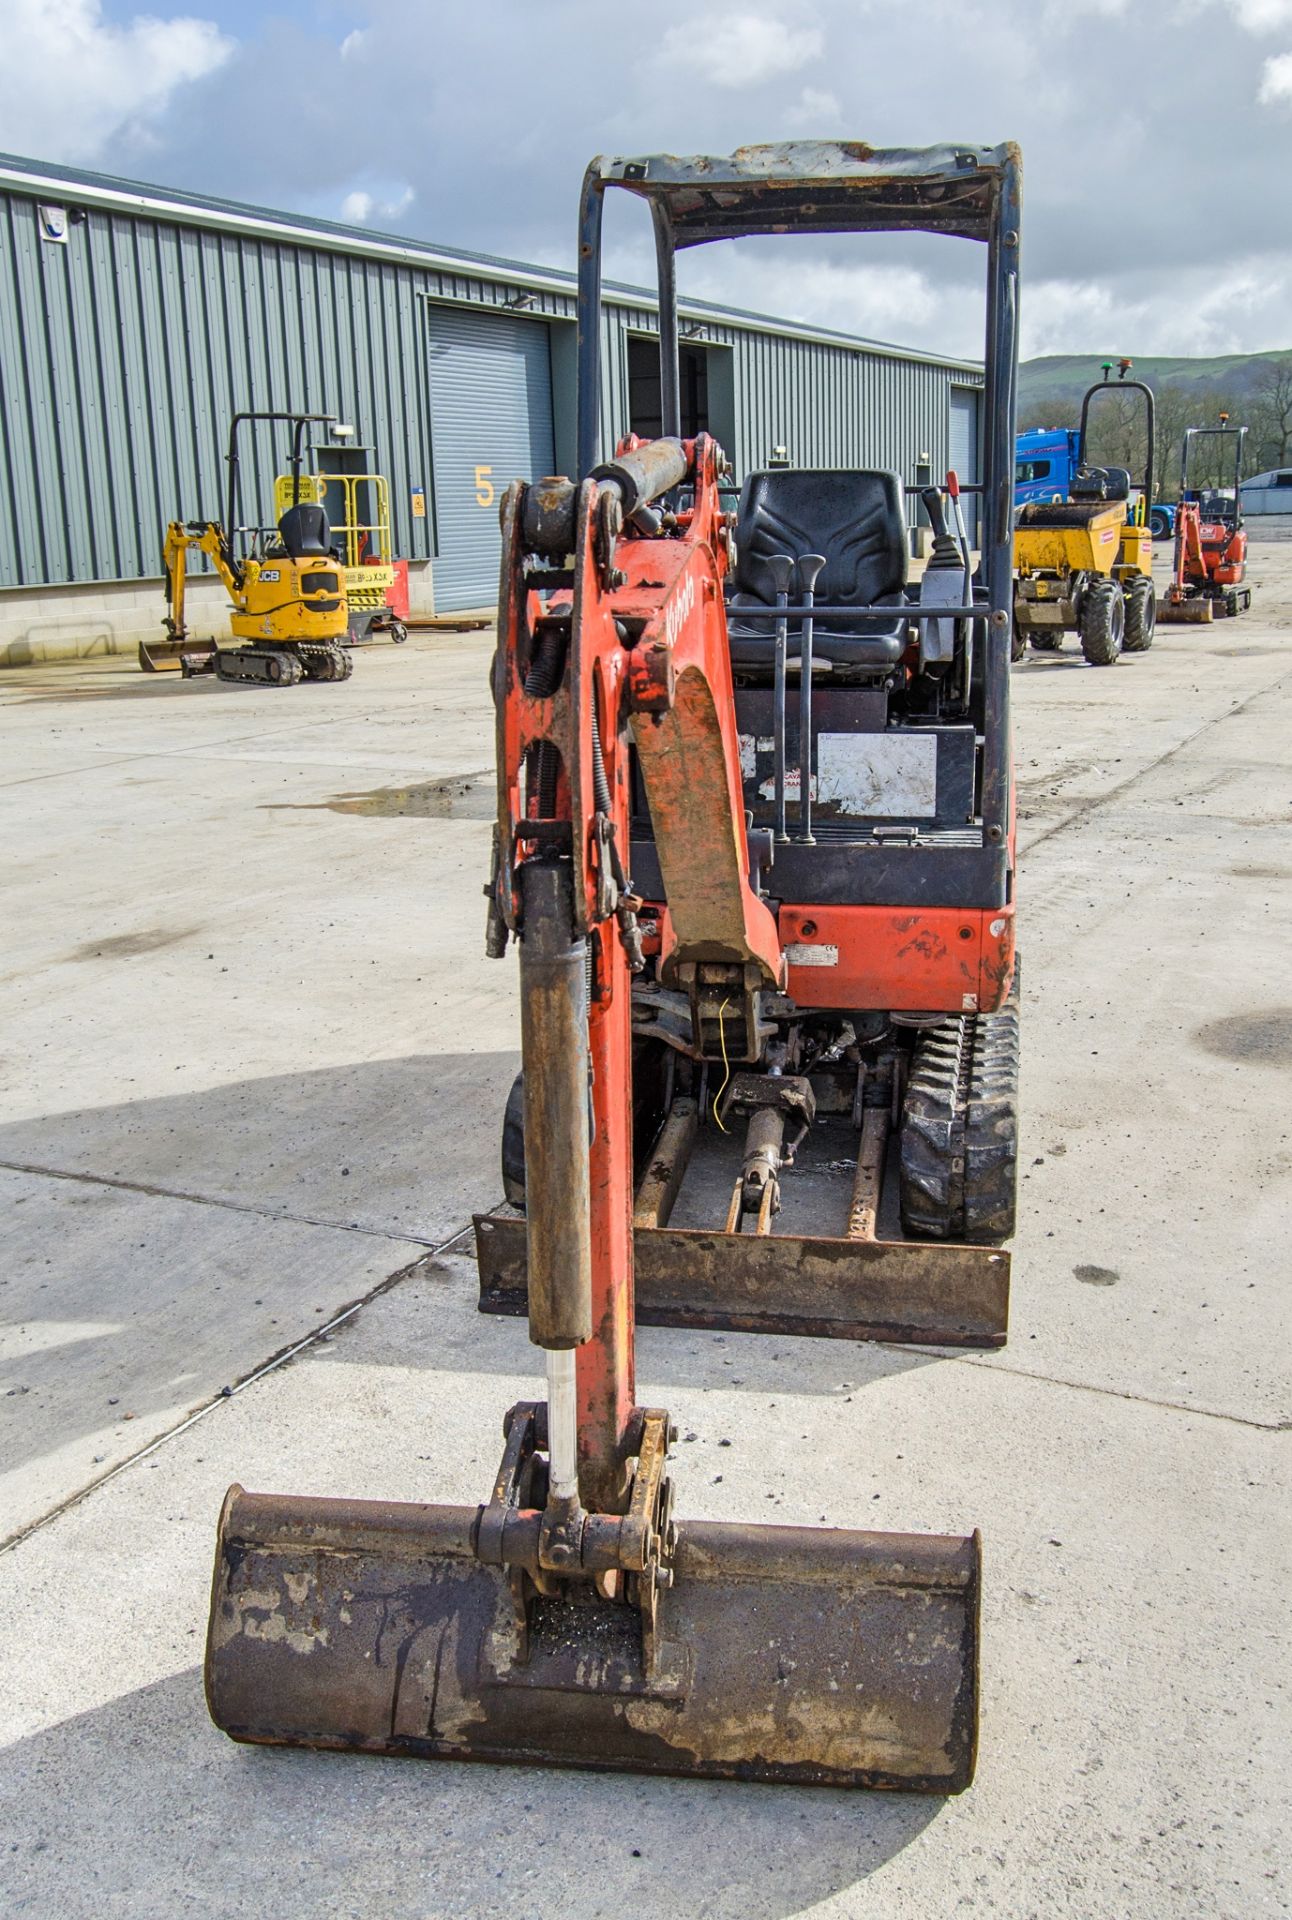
576 140 1021 845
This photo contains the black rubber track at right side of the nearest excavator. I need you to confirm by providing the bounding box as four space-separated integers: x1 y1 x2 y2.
900 972 1019 1244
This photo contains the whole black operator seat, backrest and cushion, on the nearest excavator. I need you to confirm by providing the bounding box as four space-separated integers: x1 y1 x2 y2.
728 467 908 672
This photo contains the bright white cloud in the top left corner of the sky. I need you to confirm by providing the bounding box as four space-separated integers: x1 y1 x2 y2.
0 0 234 161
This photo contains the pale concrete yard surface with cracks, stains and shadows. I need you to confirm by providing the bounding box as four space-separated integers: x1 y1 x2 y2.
0 536 1292 1920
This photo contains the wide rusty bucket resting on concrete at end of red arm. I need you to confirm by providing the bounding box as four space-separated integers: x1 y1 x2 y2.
205 1486 979 1793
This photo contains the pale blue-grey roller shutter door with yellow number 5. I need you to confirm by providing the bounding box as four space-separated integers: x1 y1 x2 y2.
430 307 555 612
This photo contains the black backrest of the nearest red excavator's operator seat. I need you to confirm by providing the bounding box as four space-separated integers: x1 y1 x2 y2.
733 467 908 607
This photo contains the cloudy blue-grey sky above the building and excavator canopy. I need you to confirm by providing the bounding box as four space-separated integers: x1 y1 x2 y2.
0 0 1292 355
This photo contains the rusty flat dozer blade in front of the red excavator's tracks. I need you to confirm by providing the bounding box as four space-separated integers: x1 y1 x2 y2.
476 1213 1010 1346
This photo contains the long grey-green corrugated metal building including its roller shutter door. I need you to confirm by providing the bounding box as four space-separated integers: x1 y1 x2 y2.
0 157 981 645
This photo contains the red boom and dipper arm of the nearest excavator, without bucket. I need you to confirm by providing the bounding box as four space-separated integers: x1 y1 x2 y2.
491 436 785 1507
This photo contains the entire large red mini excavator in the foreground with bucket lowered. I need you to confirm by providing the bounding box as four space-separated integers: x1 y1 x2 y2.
205 142 1019 1793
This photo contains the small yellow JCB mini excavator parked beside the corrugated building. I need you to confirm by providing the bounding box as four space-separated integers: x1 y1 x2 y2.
138 413 353 687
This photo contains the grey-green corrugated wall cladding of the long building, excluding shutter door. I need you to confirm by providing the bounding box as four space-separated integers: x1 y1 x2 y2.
0 184 979 588
